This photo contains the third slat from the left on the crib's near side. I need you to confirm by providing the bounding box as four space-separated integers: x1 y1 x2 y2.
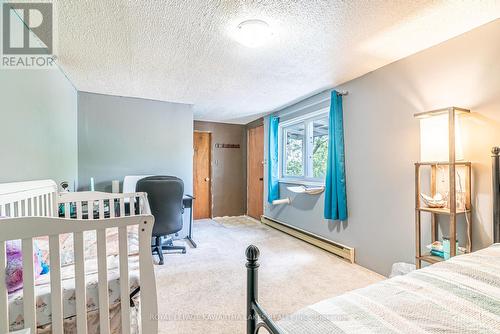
49 235 63 334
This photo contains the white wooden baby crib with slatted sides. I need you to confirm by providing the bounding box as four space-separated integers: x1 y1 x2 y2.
0 180 158 334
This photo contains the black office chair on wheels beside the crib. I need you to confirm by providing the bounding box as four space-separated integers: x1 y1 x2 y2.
136 176 186 265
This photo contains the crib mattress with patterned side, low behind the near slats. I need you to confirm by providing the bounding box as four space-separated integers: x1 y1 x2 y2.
9 255 139 331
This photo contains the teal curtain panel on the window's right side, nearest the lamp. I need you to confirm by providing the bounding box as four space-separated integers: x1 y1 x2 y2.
325 91 347 220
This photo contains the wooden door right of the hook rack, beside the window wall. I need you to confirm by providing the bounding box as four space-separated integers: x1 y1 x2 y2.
247 125 264 220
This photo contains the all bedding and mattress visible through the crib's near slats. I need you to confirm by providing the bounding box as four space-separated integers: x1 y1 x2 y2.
9 229 139 333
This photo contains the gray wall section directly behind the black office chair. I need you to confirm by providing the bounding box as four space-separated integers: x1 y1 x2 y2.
78 92 193 232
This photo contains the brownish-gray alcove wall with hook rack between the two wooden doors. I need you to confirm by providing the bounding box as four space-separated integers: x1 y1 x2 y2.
194 121 247 217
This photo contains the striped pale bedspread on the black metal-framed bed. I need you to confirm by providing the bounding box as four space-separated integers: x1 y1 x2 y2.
279 244 500 334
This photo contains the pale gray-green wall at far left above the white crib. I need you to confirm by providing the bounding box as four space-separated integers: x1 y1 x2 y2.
0 68 78 188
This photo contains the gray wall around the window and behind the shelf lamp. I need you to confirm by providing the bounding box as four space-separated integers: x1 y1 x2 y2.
264 20 500 275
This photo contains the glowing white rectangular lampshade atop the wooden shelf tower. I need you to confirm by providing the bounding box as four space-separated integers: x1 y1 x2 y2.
415 107 470 162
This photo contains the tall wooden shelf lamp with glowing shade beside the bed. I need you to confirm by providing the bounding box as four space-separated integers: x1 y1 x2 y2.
415 107 472 269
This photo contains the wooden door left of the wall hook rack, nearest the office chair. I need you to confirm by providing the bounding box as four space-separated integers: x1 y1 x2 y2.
193 132 212 219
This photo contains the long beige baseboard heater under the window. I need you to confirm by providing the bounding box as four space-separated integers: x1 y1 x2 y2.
261 216 354 263
